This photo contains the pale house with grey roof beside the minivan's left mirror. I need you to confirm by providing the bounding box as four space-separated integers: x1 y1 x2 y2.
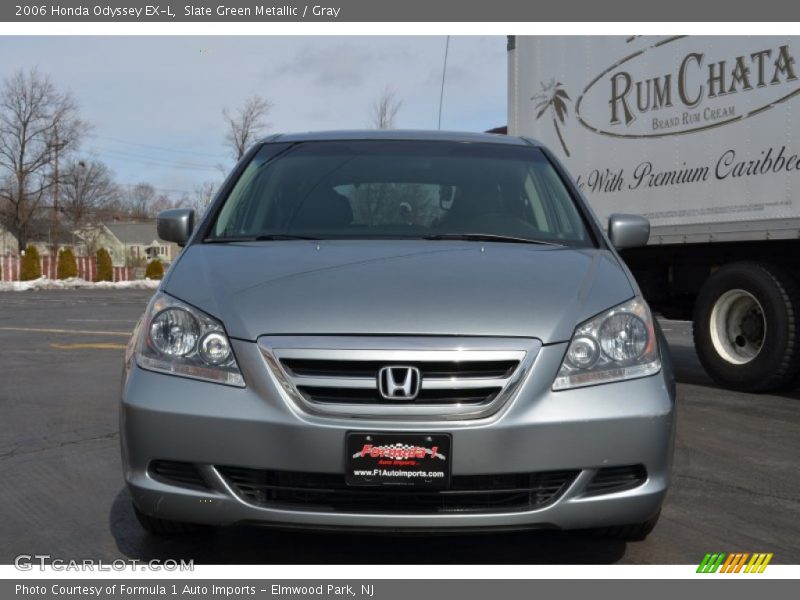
75 220 180 267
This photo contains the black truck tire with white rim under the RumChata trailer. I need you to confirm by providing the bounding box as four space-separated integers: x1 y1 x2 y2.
693 262 800 392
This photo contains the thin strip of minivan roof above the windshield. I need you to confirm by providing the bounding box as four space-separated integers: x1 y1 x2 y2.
262 129 541 146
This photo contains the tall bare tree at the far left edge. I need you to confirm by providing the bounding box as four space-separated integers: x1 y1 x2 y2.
0 69 86 251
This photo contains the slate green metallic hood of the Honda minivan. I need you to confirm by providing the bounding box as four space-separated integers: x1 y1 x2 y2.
163 240 634 343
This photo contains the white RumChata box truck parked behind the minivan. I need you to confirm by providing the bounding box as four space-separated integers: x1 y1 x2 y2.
508 36 800 391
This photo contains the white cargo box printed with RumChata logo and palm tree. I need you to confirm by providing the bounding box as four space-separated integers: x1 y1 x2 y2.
509 36 800 244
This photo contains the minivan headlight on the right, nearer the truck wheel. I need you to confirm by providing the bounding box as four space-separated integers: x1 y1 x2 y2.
553 298 661 390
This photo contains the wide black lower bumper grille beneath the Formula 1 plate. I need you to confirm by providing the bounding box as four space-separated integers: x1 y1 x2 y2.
216 467 578 514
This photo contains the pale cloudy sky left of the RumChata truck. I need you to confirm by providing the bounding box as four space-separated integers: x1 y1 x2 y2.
0 36 506 193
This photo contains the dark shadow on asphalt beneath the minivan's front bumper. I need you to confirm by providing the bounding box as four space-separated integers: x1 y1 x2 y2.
109 488 626 565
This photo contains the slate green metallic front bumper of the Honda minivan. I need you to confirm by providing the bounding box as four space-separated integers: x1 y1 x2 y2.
120 340 675 531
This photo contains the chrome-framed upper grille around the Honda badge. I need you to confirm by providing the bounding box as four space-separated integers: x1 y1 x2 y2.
259 336 541 418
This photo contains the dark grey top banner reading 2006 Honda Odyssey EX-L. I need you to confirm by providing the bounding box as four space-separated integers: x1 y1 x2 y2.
0 0 800 22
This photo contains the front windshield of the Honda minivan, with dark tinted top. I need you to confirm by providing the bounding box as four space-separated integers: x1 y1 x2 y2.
206 140 593 246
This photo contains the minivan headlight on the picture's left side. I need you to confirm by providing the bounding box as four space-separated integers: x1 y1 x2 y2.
136 292 244 387
